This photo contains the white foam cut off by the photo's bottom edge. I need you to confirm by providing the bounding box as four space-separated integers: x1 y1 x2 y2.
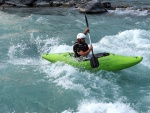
62 101 137 113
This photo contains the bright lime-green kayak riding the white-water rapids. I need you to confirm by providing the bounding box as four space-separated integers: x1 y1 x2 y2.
42 52 143 71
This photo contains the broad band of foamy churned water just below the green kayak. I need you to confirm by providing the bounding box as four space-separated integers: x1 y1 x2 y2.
40 62 120 100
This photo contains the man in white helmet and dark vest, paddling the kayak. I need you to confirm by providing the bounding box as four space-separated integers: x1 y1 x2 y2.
73 28 93 57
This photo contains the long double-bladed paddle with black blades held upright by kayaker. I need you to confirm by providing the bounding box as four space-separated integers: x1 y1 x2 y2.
85 13 99 68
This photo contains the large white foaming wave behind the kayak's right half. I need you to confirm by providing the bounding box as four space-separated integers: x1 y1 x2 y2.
93 29 150 68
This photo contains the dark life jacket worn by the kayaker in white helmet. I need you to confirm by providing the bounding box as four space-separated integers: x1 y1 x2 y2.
73 42 89 57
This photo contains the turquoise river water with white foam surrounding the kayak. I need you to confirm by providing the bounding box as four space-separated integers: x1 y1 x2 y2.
0 8 150 113
